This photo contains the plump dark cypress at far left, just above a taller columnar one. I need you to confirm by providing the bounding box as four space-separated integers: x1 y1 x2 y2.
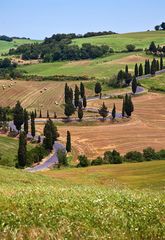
13 101 24 131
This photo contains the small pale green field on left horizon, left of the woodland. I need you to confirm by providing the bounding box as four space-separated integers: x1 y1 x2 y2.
0 39 41 55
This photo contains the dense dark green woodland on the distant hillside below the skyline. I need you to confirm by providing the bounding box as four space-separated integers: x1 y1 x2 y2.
9 31 116 62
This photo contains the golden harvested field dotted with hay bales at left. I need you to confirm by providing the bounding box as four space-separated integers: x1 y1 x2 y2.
0 80 91 116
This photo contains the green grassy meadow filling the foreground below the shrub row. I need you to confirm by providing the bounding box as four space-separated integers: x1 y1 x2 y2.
0 161 165 240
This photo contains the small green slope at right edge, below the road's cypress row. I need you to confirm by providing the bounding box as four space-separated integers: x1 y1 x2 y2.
140 74 165 91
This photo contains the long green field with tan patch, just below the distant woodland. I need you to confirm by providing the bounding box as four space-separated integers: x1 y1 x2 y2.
19 53 152 78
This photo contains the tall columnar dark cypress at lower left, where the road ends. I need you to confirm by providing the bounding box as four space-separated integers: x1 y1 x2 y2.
18 132 26 168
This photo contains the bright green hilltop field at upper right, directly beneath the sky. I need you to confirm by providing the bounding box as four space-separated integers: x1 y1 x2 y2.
73 31 165 51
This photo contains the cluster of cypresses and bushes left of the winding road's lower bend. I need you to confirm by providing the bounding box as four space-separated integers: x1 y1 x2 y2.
13 101 59 168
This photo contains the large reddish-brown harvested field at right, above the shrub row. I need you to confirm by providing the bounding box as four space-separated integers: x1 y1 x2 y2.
59 93 165 158
